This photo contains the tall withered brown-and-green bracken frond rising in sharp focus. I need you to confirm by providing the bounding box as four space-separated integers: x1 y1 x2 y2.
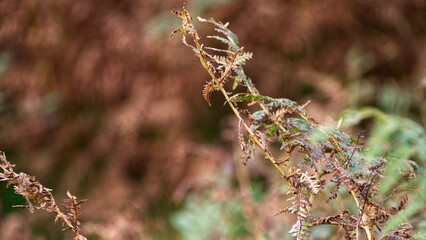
172 8 418 240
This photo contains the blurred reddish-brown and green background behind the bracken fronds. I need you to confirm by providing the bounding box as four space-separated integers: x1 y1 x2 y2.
0 0 426 240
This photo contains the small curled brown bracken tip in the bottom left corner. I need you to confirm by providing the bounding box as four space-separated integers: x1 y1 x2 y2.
0 152 86 240
